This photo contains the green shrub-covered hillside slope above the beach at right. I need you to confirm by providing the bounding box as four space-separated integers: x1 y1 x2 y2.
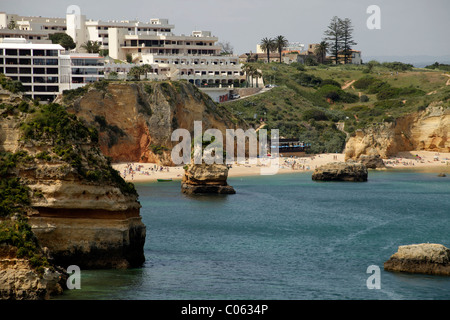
223 63 450 153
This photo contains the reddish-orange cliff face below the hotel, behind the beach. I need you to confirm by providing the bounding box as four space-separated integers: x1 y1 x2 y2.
59 81 246 165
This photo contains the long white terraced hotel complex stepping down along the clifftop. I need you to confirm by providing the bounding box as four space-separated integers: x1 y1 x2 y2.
0 12 245 98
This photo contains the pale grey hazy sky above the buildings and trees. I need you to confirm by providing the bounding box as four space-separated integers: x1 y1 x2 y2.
0 0 450 58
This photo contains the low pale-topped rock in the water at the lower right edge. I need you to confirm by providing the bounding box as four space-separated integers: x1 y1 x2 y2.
384 243 450 276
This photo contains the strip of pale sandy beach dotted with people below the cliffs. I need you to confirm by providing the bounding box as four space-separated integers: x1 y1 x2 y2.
113 151 450 182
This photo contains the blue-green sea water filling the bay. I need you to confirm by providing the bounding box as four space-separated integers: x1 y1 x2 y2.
57 171 450 300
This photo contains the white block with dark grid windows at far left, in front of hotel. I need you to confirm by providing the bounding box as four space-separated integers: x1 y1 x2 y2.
0 38 104 101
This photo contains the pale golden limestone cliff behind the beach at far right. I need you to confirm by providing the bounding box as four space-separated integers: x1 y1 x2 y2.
344 103 450 159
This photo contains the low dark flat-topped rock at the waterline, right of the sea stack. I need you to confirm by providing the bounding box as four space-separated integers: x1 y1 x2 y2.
312 162 367 182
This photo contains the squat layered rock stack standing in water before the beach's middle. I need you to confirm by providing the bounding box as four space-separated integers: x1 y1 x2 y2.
181 163 236 194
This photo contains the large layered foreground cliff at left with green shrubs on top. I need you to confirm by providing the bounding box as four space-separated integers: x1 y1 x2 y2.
0 94 145 269
